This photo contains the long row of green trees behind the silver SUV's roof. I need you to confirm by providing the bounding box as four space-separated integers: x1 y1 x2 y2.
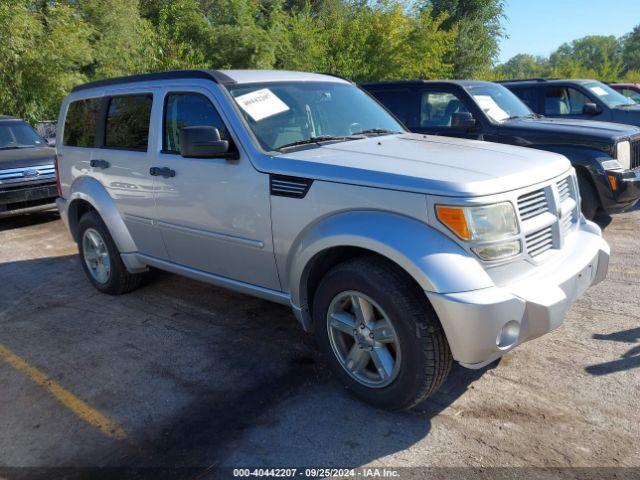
0 0 502 121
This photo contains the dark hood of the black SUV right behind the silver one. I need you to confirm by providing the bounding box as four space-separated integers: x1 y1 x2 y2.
503 117 640 143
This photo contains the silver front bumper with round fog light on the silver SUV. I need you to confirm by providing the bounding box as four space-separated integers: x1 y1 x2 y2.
426 222 609 368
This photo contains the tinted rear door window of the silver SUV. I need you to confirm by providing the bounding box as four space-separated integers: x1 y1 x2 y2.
104 94 153 151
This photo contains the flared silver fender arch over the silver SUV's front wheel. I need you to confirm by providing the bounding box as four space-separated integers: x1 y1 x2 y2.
286 211 493 329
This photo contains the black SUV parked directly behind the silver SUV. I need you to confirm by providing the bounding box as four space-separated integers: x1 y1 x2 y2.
362 81 640 219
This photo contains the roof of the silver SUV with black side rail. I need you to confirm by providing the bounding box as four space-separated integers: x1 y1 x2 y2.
72 70 350 92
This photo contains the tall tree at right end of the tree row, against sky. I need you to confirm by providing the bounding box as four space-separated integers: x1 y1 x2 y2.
426 0 506 78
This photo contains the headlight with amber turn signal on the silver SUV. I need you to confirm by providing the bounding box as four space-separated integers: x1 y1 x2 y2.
436 202 522 260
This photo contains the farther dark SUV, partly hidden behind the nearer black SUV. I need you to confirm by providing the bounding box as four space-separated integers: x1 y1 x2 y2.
500 78 640 126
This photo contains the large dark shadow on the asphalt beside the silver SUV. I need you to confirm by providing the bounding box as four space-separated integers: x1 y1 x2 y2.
0 255 495 478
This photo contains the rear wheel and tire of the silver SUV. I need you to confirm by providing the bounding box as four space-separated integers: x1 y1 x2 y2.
78 212 142 295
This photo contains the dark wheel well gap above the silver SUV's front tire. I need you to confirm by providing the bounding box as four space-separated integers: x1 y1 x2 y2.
300 246 428 318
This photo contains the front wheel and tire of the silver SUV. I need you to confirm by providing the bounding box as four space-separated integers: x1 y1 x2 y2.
313 257 453 410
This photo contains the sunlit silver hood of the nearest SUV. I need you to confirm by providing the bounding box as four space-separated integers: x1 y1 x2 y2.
265 133 571 196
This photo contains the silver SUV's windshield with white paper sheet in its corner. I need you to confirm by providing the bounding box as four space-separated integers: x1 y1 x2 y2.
227 82 405 151
